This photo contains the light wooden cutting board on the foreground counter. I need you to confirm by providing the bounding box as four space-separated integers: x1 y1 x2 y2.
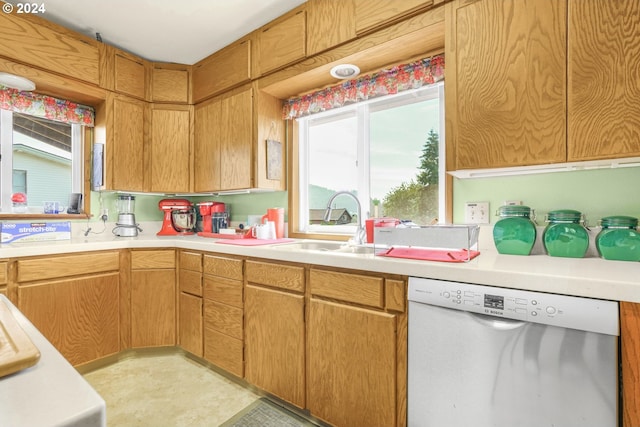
0 301 40 378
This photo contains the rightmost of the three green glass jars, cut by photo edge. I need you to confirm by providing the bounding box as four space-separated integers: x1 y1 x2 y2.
596 216 640 261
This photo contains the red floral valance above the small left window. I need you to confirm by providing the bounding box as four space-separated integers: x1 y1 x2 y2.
0 86 95 127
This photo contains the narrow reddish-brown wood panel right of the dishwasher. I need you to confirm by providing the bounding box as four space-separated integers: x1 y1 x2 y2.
620 302 640 427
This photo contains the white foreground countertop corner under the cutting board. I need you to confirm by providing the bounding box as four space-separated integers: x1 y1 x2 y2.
0 295 107 427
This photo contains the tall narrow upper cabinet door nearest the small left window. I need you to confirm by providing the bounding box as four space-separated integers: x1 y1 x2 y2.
112 96 148 191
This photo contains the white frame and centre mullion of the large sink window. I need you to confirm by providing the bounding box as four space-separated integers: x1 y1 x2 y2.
287 82 444 240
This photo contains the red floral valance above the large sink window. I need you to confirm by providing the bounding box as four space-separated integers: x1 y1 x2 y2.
283 55 444 120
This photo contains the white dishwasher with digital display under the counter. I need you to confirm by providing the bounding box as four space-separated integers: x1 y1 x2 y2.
407 277 619 427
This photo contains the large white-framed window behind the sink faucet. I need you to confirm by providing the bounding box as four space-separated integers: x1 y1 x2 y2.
294 83 445 235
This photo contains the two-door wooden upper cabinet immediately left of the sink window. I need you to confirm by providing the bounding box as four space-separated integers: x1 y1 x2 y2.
194 83 286 192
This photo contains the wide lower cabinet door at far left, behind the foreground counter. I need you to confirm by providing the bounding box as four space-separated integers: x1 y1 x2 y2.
18 273 120 365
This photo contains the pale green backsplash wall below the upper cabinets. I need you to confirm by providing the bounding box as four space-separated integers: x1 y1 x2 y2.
91 167 640 229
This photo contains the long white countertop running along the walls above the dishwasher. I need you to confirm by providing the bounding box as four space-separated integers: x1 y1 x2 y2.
0 223 640 303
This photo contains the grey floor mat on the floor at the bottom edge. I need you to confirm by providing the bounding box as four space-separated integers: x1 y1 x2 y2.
220 397 317 427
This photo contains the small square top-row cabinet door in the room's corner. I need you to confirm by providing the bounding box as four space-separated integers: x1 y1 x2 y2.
151 63 190 104
